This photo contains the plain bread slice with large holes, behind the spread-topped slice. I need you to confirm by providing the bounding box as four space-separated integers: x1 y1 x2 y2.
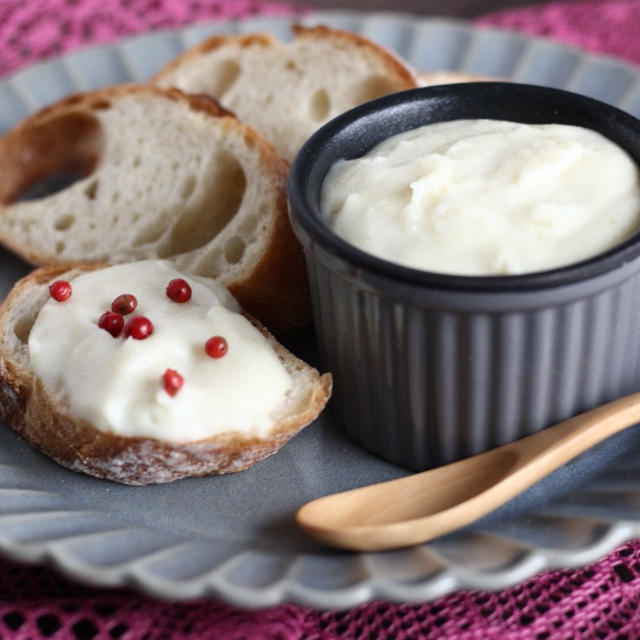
0 85 310 332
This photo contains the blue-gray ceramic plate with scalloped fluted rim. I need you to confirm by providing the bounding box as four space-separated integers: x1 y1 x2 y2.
0 12 640 608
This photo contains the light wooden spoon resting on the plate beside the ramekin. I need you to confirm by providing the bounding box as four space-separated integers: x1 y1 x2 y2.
296 392 640 551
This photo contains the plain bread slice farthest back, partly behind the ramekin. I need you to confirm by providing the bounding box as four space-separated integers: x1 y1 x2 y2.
152 26 418 161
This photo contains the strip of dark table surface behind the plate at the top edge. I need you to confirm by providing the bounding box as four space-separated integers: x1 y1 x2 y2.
292 0 543 18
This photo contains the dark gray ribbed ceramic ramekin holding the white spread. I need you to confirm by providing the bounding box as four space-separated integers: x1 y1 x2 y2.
290 83 640 470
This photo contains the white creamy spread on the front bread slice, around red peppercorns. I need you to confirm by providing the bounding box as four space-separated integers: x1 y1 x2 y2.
29 261 292 442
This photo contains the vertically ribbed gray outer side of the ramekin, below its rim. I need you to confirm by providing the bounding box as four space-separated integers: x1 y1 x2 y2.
308 259 640 469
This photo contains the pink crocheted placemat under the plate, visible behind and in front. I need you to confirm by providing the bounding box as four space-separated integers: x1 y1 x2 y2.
0 0 640 640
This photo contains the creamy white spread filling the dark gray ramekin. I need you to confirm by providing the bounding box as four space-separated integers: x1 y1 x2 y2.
321 120 640 275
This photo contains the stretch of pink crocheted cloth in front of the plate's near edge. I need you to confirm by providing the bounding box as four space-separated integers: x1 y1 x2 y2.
0 542 640 640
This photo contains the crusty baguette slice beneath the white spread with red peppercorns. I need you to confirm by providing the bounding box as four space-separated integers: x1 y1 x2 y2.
0 265 331 485
